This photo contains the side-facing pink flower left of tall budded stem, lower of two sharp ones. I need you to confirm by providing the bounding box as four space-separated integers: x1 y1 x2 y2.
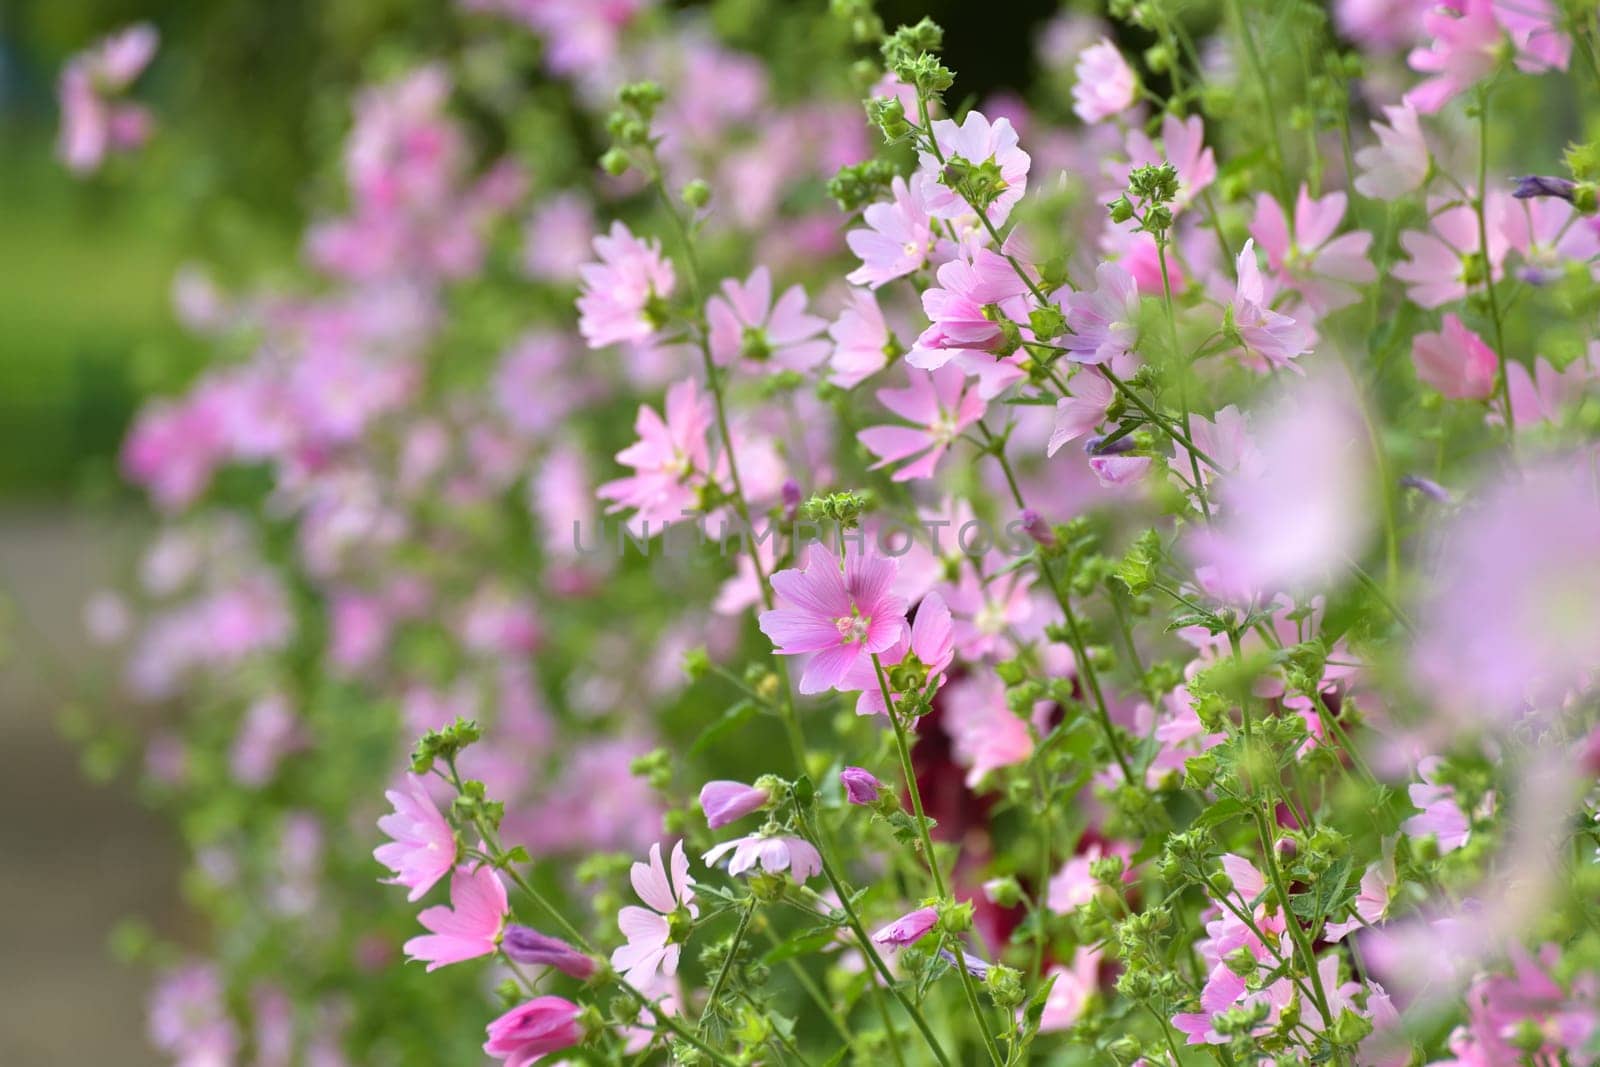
597 378 715 530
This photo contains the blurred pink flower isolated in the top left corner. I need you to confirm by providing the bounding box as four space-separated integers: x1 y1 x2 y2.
56 22 157 174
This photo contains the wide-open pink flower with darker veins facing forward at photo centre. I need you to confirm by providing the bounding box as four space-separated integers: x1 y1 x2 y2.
760 545 906 693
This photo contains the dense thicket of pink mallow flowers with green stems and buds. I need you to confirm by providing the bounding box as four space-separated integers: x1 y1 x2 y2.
62 0 1600 1067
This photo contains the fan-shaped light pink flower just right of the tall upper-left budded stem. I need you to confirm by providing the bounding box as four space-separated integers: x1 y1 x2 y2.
706 267 829 371
